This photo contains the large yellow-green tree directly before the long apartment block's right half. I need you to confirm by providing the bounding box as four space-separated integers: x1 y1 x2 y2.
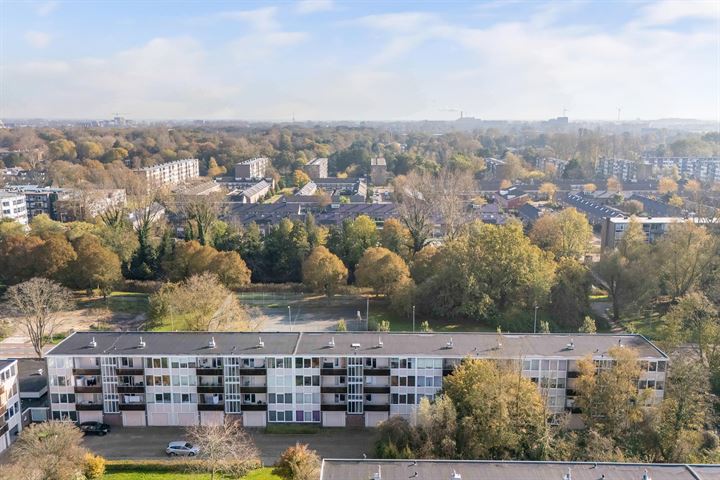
443 359 548 459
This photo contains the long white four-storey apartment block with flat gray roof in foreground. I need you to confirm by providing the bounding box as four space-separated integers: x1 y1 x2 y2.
47 332 668 427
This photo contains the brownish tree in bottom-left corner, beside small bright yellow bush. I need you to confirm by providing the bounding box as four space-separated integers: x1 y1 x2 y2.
8 420 86 480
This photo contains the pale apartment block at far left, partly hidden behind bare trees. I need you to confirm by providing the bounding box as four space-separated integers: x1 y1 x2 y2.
55 189 127 222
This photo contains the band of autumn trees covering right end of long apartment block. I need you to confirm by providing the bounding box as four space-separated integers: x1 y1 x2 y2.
376 347 720 463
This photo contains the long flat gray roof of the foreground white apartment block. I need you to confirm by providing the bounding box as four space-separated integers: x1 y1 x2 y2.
48 332 665 358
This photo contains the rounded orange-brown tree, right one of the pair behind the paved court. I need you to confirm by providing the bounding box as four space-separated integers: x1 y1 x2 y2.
355 247 410 295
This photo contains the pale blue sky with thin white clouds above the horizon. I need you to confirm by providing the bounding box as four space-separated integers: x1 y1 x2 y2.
0 0 720 122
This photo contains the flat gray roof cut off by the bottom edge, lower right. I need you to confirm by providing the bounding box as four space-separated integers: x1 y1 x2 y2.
320 459 720 480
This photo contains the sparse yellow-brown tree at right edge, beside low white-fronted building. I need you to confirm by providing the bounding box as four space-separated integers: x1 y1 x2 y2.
658 221 718 299
